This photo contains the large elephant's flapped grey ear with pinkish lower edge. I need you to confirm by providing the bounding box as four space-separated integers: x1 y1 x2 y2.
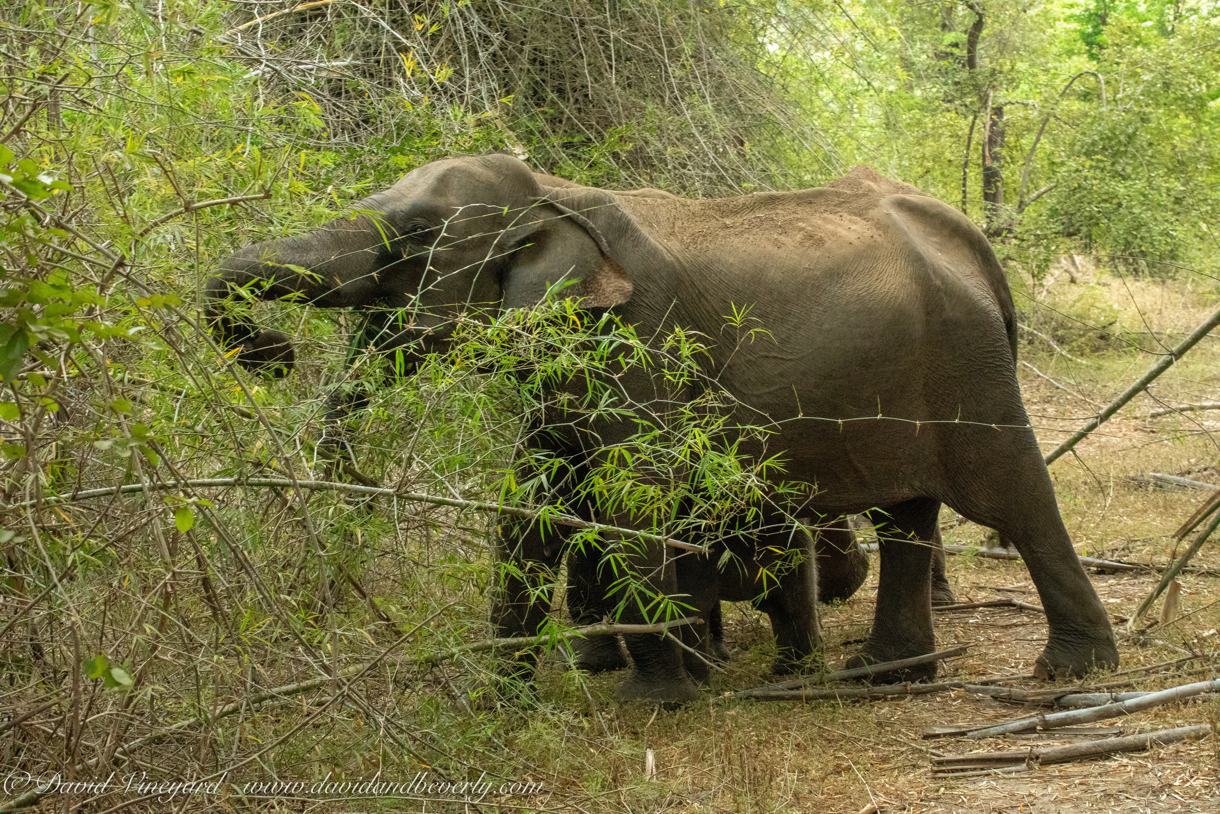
503 190 632 309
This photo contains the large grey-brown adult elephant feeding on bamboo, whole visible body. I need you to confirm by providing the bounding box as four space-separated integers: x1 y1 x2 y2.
207 156 1118 703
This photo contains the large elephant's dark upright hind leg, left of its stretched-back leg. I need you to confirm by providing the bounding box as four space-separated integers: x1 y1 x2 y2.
847 498 941 682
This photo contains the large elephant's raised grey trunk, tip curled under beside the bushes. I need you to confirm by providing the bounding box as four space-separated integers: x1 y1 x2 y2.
204 208 393 376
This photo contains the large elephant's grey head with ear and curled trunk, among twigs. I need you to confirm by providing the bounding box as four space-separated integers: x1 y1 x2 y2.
206 155 641 375
